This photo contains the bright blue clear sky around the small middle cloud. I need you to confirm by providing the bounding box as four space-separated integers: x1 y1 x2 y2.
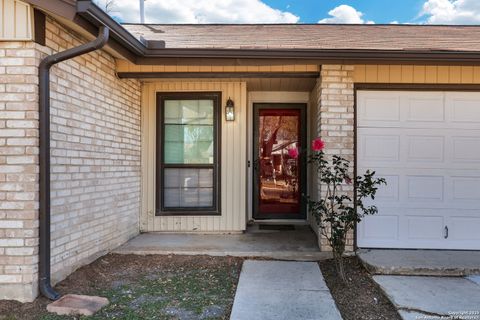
264 0 426 23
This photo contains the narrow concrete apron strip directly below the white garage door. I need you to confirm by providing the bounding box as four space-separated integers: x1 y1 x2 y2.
358 249 480 276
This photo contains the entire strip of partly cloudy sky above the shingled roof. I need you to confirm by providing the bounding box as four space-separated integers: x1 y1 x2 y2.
97 0 480 24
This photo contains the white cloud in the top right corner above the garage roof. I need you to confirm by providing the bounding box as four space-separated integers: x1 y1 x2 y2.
421 0 480 24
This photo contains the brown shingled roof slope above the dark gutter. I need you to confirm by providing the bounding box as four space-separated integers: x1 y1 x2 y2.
123 24 480 52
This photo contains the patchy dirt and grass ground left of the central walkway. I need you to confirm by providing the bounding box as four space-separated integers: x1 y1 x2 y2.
0 254 243 320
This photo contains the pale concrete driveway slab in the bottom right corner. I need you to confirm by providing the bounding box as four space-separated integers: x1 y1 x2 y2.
373 276 480 320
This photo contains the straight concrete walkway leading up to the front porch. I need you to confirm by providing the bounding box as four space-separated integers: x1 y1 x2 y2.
230 260 342 320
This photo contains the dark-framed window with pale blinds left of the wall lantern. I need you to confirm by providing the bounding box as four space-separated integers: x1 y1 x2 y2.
156 92 221 215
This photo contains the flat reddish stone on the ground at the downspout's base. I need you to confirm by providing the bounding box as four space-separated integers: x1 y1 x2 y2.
47 294 108 316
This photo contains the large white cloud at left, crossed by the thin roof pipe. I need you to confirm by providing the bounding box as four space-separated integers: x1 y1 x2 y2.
107 0 299 23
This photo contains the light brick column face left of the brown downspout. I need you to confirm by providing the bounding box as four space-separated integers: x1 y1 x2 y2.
0 42 40 301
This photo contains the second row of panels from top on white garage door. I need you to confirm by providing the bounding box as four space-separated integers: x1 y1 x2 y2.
357 130 480 170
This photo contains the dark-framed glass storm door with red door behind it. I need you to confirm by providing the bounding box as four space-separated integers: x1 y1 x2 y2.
253 104 306 219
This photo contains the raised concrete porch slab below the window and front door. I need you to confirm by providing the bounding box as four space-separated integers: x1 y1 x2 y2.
114 227 331 261
